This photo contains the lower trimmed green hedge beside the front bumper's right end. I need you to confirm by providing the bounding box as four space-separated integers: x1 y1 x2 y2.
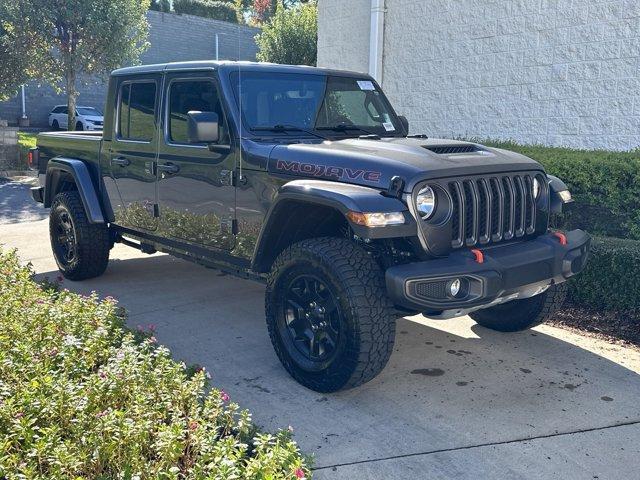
569 237 640 312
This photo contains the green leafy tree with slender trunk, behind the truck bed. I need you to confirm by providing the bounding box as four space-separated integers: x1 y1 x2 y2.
0 0 150 130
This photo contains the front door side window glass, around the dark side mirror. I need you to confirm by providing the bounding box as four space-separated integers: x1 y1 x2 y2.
167 80 228 143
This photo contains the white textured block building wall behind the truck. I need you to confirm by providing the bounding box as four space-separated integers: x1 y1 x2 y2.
318 0 640 150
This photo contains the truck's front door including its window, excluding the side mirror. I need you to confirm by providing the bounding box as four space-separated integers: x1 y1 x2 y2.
157 72 236 251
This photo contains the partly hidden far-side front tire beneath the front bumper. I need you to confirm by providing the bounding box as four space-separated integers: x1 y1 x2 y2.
469 283 567 332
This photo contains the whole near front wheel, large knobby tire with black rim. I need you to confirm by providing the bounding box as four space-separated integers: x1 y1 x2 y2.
265 237 395 392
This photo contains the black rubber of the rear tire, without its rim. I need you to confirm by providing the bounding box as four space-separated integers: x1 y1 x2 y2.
49 190 111 280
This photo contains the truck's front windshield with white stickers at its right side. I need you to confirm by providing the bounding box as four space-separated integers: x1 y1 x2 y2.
231 72 402 136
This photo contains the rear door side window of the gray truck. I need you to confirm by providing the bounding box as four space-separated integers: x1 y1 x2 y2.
118 82 156 142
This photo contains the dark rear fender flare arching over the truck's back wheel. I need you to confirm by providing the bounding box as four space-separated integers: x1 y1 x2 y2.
43 157 105 223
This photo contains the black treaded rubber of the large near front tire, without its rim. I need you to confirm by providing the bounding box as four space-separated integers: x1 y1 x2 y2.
265 237 396 392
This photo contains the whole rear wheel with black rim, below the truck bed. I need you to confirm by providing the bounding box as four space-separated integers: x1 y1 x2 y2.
49 191 111 280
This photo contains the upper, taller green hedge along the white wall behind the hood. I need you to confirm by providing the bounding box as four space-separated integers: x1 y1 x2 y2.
480 141 640 240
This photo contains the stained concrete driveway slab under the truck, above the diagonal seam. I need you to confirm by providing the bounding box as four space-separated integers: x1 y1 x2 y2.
33 255 640 467
